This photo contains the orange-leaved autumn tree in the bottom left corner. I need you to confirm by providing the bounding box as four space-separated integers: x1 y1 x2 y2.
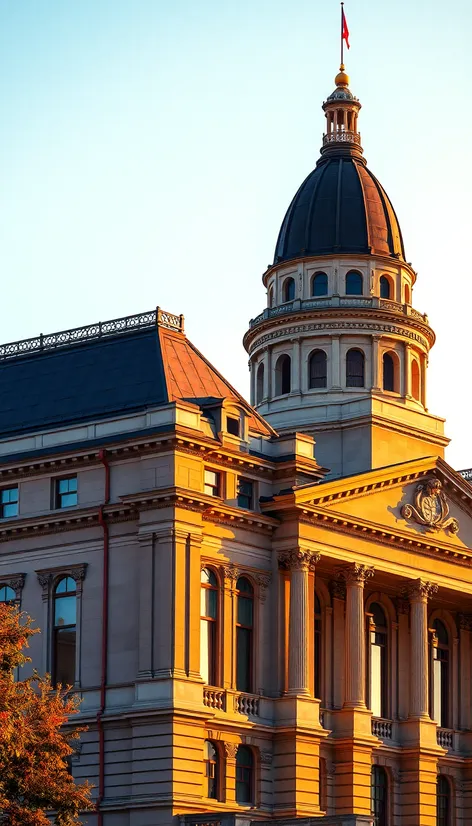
0 603 91 826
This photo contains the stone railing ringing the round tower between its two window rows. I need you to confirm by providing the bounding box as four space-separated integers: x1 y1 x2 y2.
249 295 428 328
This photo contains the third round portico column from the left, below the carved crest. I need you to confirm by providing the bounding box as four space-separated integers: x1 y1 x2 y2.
405 579 438 720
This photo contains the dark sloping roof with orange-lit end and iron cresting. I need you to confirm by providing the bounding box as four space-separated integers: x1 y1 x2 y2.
0 309 274 438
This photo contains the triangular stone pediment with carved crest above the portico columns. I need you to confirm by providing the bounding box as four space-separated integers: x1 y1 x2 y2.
297 457 472 559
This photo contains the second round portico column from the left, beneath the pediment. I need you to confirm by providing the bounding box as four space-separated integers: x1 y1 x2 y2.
340 563 374 708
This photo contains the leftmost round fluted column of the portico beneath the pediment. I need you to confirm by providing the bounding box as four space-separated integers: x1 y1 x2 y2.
279 549 320 697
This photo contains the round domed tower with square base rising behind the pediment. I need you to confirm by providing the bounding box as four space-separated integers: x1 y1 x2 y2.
244 65 448 476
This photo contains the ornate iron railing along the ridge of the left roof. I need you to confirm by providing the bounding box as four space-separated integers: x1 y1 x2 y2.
0 307 184 360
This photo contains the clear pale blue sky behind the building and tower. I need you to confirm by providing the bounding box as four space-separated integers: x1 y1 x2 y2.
0 0 472 468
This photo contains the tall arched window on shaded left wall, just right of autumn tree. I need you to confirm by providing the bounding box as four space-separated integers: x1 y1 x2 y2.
53 576 77 686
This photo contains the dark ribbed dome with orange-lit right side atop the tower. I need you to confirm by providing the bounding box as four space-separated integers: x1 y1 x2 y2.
274 154 405 264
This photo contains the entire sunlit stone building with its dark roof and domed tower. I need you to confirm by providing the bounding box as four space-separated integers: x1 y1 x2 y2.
0 70 472 826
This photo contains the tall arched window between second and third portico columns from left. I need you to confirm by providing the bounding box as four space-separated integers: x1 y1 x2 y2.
369 602 388 717
